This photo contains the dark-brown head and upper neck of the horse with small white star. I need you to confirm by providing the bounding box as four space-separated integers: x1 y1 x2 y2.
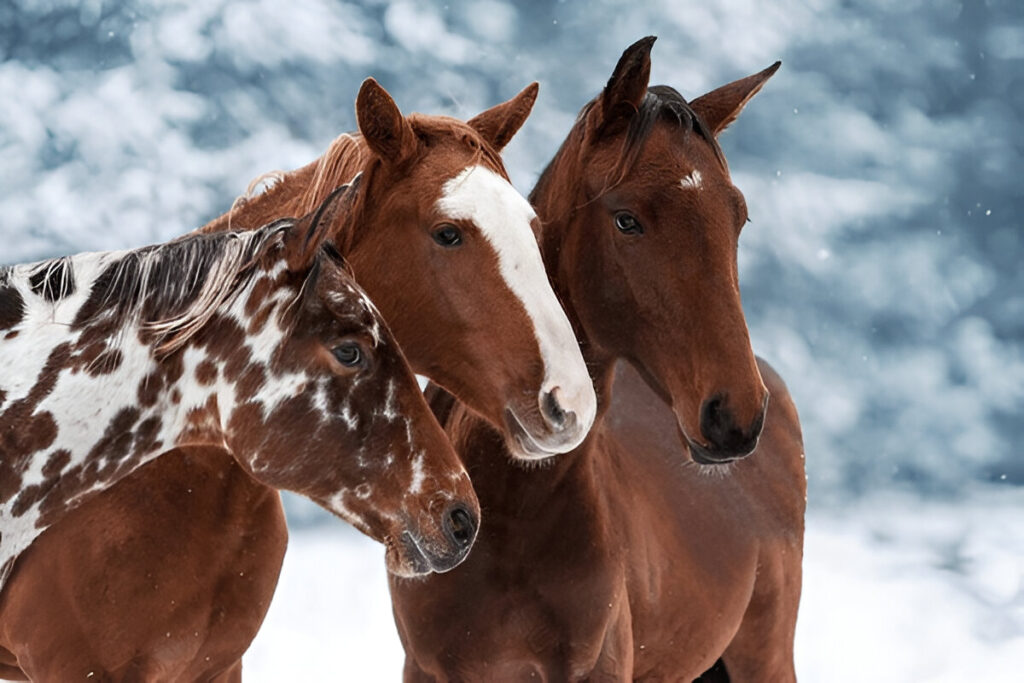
531 38 778 464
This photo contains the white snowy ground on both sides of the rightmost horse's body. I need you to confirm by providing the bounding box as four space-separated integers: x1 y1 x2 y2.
245 489 1024 683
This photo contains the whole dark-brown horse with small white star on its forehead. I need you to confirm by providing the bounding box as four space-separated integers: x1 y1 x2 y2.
390 38 806 682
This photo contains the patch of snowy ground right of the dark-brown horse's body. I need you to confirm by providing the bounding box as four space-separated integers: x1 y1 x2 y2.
797 490 1024 683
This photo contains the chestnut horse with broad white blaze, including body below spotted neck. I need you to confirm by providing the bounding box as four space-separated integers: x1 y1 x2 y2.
0 80 596 681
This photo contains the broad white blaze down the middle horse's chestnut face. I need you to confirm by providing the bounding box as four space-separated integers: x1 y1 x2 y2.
437 166 597 452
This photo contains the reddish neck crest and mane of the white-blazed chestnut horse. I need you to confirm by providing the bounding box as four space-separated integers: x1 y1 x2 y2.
199 133 371 237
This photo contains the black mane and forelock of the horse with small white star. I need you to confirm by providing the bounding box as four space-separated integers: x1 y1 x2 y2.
529 85 726 205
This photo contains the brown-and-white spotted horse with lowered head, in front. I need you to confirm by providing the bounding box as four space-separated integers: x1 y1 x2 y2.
0 184 479 680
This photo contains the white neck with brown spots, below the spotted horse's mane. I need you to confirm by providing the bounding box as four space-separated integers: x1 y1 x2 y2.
0 252 292 589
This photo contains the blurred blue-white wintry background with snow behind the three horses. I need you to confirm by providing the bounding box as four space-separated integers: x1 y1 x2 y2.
0 0 1024 681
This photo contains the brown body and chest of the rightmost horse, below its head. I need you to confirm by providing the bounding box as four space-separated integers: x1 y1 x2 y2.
392 361 804 681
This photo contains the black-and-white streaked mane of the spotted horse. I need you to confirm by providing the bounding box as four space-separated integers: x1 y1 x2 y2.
72 219 294 353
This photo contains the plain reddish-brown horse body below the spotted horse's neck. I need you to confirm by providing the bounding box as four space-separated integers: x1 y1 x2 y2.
0 449 288 681
